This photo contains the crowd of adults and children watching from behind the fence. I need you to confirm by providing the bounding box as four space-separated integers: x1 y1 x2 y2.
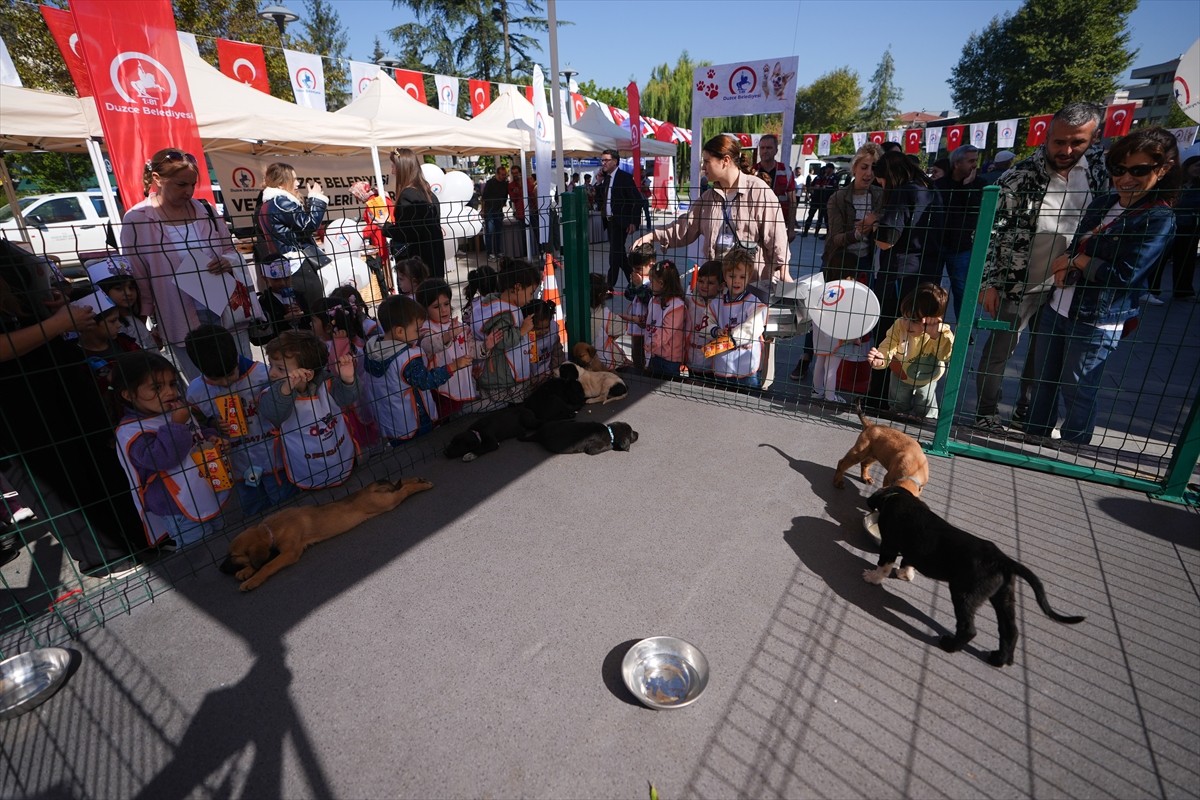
0 103 1200 575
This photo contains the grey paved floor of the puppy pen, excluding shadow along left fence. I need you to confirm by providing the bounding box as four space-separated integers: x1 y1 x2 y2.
0 385 1200 800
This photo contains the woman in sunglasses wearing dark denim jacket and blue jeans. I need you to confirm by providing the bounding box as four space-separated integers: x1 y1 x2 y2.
1026 127 1182 444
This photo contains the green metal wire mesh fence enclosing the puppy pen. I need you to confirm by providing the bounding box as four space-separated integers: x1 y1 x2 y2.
0 176 1200 655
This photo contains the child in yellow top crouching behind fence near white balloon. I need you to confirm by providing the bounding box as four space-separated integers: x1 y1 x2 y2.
866 283 954 419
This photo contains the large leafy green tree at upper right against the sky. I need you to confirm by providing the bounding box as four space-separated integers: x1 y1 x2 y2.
948 0 1138 119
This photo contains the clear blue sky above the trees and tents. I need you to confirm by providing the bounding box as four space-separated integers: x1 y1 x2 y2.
324 0 1200 117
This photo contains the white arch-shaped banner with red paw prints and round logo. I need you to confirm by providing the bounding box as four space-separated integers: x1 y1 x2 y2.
690 55 800 199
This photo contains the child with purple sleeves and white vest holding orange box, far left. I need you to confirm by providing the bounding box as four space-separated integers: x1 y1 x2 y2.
112 350 233 549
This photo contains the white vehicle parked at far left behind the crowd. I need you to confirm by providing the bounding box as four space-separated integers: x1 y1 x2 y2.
0 192 120 272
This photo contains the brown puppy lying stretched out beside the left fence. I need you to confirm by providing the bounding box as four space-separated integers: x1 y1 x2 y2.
221 477 433 591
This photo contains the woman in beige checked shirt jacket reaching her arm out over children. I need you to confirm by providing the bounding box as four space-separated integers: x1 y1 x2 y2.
634 134 792 283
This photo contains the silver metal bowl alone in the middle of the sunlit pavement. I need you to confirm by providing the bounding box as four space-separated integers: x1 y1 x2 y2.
620 636 708 709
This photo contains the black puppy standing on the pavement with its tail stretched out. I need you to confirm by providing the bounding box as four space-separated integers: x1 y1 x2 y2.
863 486 1084 667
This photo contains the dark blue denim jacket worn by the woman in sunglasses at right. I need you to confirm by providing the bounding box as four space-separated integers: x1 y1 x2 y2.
1067 192 1175 325
